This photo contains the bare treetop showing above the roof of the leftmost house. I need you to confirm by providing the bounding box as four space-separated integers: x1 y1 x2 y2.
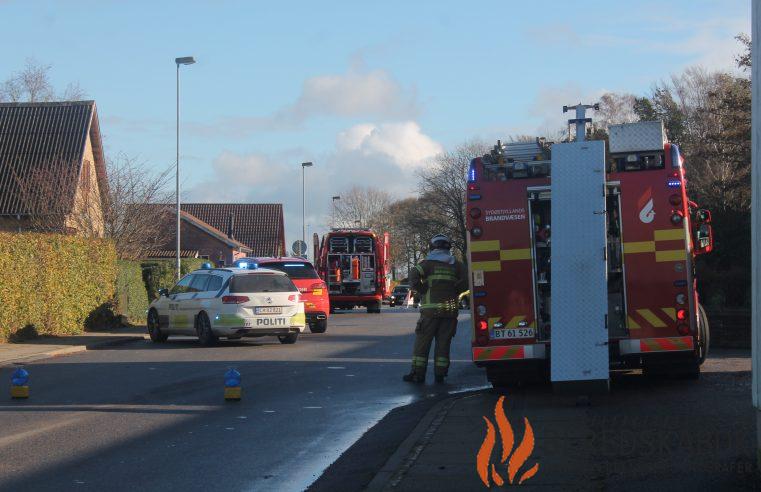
0 58 85 102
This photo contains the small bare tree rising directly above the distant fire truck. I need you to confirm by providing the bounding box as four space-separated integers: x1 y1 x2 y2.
334 186 392 233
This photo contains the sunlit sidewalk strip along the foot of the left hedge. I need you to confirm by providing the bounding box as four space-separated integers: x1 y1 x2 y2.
0 326 147 367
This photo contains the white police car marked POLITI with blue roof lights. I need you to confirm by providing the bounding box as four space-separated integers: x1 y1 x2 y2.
147 263 306 346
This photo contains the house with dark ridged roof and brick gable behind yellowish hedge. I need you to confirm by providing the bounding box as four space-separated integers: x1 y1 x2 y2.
0 101 108 236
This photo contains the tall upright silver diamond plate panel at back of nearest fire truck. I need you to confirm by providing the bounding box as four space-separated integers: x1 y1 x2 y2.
550 141 609 382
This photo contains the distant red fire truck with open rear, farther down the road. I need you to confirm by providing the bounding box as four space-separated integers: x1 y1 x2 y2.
314 228 389 313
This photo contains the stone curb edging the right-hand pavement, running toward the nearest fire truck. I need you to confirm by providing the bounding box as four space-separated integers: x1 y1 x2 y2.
364 394 460 492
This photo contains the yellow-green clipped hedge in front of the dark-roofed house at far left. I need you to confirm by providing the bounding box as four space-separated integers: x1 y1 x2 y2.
0 232 116 341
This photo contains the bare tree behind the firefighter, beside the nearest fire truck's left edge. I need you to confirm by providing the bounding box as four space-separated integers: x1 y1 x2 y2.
418 140 489 258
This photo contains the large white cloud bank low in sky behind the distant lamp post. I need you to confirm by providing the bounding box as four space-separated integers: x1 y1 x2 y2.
184 121 443 244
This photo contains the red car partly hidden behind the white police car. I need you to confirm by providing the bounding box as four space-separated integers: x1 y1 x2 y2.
235 258 330 333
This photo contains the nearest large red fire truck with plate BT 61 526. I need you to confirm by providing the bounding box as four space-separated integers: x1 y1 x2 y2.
467 105 713 391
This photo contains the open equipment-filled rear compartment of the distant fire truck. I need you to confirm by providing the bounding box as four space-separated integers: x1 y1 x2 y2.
327 236 376 295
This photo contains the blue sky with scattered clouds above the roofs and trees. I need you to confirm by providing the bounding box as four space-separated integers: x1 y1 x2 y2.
0 0 750 248
